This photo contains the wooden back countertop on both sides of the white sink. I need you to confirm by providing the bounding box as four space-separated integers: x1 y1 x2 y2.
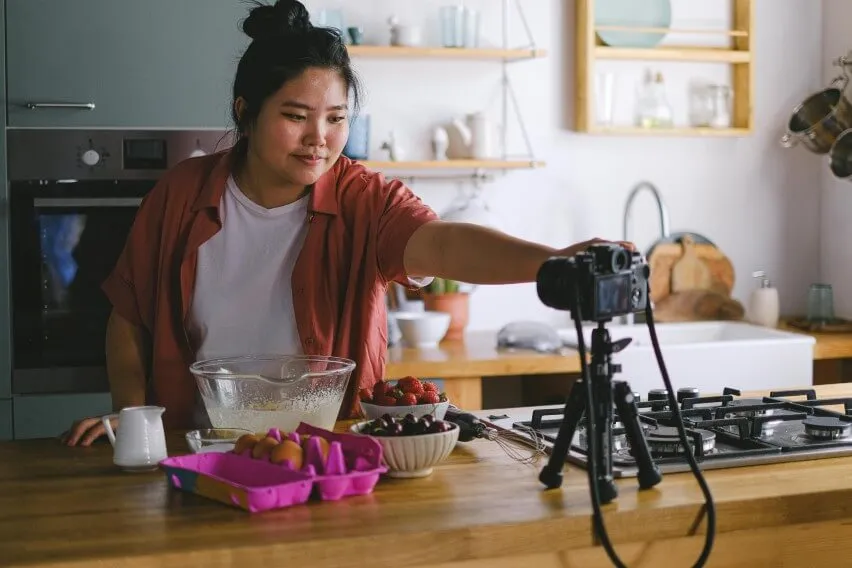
386 323 852 379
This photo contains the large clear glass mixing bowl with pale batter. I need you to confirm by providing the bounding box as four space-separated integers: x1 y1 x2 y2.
189 355 355 432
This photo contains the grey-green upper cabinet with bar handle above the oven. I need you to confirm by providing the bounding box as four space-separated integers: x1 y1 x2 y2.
6 0 250 128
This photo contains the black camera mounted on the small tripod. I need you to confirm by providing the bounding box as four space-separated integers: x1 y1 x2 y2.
536 244 651 322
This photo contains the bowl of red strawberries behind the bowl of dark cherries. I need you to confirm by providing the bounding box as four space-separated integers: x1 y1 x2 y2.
358 377 450 420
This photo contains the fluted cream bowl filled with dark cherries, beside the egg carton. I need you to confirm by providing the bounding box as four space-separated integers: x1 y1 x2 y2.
350 414 459 478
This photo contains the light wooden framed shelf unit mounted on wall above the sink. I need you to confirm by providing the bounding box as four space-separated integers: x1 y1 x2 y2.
574 0 754 136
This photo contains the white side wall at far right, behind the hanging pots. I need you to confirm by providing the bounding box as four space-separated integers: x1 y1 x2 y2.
812 0 852 318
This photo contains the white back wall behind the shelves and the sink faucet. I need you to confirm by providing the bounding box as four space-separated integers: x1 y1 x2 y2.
307 0 824 329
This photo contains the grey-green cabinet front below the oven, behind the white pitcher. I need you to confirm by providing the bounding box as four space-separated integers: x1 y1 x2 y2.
13 393 112 440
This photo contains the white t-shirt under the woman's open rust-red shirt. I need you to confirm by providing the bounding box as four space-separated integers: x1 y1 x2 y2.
188 177 309 360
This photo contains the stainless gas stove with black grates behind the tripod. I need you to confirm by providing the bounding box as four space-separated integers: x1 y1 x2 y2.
487 388 852 477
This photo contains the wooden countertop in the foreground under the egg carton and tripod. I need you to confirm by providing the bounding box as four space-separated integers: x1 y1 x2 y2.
5 385 852 568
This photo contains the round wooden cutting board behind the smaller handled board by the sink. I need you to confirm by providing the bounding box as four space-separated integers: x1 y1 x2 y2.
648 237 735 303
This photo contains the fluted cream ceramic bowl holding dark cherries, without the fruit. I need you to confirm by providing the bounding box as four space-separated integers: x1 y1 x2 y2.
350 422 459 478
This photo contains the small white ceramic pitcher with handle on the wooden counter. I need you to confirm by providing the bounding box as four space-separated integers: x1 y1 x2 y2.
101 406 168 471
